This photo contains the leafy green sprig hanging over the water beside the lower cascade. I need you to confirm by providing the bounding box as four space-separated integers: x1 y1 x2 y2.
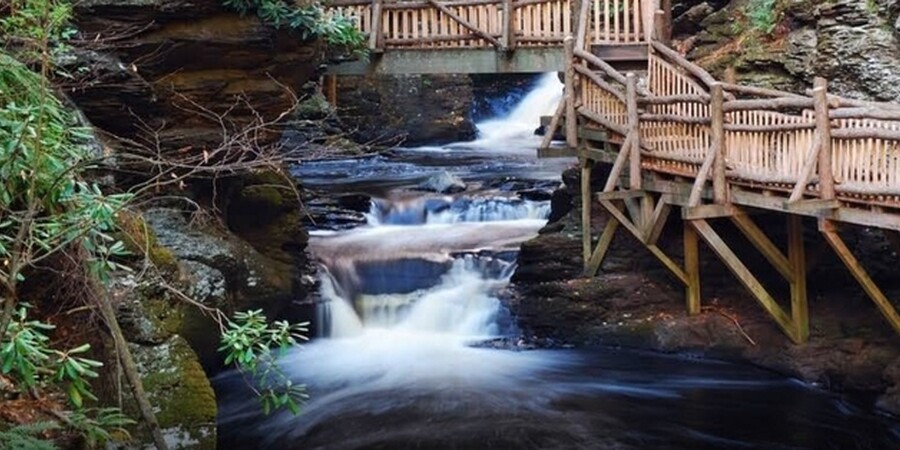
219 310 308 414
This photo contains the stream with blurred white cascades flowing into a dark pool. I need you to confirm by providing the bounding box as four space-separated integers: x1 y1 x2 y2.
214 74 900 450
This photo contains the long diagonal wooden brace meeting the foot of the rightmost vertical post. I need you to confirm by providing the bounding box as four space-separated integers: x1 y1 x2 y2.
690 220 800 343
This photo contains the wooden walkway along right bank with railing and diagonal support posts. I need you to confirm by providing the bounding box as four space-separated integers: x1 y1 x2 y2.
544 22 900 343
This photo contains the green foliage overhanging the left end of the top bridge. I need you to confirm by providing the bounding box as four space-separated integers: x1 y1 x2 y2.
222 0 365 53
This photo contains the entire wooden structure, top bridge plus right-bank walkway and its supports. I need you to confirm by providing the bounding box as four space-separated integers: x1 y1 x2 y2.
331 0 900 343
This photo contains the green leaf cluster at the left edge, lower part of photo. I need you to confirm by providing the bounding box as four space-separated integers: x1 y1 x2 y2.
0 307 103 408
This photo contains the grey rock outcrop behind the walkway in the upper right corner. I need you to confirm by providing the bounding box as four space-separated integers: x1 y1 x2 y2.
675 0 900 101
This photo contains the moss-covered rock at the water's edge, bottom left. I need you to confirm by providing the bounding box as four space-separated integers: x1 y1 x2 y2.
120 335 217 450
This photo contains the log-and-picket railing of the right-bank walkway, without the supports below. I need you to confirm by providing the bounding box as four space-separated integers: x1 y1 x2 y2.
571 38 900 208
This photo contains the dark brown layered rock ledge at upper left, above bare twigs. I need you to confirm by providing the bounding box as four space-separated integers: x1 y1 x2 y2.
68 0 321 151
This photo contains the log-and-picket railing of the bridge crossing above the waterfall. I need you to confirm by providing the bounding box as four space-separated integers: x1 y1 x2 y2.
326 0 655 52
